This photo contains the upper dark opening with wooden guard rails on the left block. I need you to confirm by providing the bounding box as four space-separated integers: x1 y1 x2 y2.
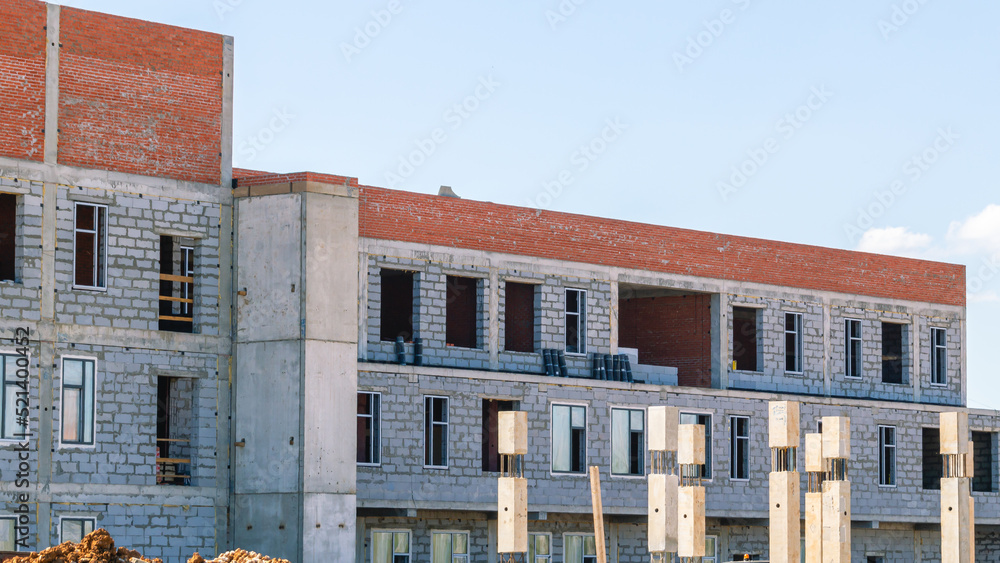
159 236 194 332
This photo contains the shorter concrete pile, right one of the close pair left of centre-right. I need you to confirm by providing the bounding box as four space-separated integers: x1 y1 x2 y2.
677 424 705 563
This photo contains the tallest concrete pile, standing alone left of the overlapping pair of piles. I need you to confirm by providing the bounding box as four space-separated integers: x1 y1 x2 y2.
768 401 801 563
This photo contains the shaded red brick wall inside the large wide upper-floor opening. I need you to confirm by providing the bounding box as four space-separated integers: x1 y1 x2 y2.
618 295 712 387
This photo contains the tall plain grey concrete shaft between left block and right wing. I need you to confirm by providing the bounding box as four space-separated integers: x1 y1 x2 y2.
233 182 358 563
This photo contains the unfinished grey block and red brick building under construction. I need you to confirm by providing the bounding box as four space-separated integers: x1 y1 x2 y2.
0 0 1000 563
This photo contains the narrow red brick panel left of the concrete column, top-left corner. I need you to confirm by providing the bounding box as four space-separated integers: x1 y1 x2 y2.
0 0 46 162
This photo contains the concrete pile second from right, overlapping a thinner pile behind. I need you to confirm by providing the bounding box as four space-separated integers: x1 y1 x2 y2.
823 416 851 563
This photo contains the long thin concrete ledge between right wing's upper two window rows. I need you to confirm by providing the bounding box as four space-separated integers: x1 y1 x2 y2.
358 361 976 416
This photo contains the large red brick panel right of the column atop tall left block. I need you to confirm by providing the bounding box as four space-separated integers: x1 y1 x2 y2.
57 5 223 184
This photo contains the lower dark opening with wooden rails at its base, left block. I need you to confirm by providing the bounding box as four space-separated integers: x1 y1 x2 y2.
156 376 194 485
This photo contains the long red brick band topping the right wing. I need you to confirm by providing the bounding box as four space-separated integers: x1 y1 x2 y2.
359 187 965 306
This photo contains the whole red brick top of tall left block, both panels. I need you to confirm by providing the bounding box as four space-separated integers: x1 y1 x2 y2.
0 0 228 185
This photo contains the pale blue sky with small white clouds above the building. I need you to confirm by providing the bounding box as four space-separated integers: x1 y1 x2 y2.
56 0 1000 408
